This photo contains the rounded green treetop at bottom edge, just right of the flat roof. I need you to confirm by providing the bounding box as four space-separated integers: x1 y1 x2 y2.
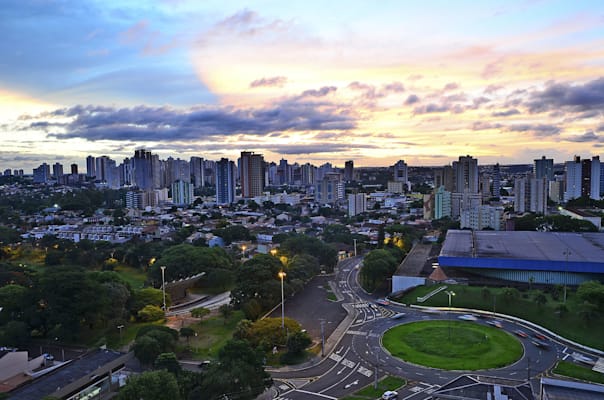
117 370 181 400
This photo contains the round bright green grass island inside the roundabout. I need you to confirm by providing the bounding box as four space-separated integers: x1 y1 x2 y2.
382 320 523 371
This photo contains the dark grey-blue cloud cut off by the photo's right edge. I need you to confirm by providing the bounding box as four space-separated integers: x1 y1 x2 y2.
526 78 604 113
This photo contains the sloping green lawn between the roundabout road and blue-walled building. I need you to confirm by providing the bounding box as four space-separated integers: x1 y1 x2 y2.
397 285 604 350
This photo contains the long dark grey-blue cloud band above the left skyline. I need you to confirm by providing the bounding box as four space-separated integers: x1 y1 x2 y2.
37 99 356 141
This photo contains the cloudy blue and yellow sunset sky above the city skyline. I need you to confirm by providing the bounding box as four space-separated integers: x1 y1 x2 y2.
0 0 604 173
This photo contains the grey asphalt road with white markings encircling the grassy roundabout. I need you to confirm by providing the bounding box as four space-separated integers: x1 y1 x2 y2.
271 259 593 400
